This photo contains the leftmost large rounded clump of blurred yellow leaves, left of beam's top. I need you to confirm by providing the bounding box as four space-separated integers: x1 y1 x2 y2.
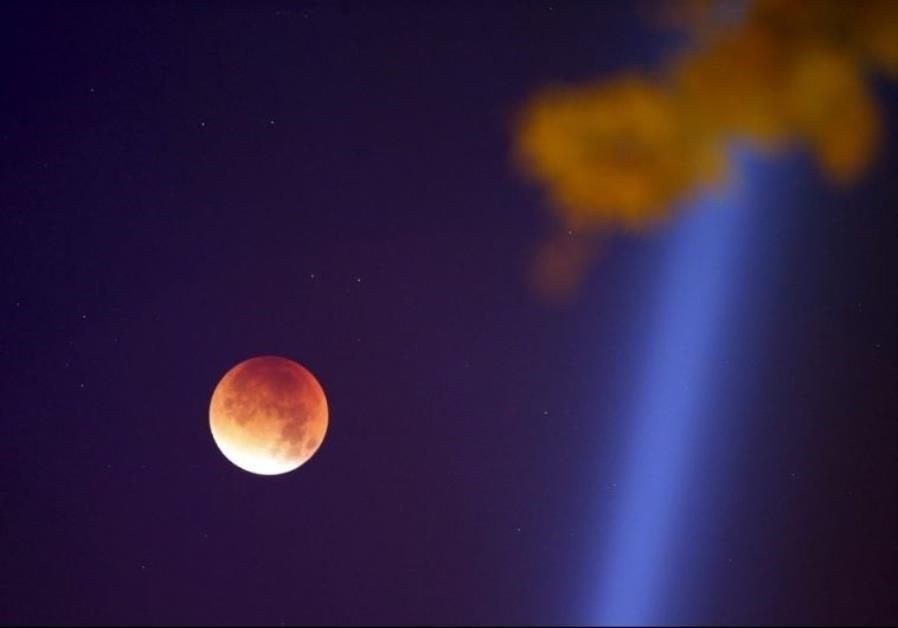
518 77 723 228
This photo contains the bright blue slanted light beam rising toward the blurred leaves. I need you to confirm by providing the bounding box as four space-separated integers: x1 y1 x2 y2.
592 169 750 625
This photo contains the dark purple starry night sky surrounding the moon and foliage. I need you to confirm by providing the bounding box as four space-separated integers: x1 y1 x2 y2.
0 2 898 624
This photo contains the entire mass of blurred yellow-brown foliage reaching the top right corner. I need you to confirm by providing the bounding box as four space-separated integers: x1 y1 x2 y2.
514 0 898 300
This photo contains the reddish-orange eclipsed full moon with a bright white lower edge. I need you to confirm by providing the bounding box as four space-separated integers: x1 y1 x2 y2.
209 356 328 475
